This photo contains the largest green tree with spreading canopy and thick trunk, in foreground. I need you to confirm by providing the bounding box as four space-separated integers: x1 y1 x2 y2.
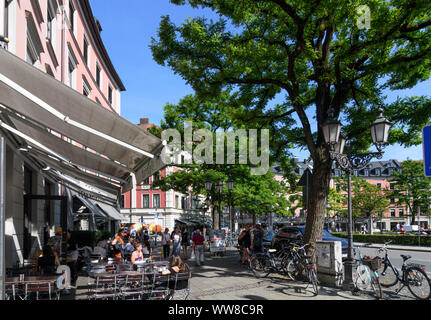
151 0 431 252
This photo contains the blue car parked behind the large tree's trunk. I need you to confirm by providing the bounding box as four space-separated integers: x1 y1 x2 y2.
272 226 349 258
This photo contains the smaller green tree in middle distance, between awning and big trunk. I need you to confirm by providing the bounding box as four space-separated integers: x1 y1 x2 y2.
153 92 294 229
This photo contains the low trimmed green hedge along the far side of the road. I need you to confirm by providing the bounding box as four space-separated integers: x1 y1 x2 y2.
332 232 431 247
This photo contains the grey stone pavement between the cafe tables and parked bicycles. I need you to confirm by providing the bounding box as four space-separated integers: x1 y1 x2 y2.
67 248 418 301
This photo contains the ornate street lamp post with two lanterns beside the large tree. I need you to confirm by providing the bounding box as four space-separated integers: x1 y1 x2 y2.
322 109 392 290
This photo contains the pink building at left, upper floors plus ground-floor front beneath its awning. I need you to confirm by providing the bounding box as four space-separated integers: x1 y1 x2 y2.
0 0 125 267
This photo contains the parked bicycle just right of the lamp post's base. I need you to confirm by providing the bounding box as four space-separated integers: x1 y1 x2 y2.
353 244 383 299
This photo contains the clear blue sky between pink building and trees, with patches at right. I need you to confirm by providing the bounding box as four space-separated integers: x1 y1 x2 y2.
90 0 431 160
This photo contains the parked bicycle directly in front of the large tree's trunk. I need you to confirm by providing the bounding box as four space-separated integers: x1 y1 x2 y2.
286 243 319 296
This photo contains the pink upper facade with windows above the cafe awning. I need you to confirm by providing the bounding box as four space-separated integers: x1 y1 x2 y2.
0 0 125 114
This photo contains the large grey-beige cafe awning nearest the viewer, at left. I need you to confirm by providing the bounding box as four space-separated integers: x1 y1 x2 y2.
0 49 164 191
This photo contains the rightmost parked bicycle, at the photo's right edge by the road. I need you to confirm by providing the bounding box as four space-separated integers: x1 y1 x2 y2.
377 241 431 300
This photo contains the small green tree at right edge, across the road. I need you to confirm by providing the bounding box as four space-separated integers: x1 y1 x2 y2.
389 160 431 224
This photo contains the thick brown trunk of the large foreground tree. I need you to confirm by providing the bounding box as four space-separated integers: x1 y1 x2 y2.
304 146 332 254
